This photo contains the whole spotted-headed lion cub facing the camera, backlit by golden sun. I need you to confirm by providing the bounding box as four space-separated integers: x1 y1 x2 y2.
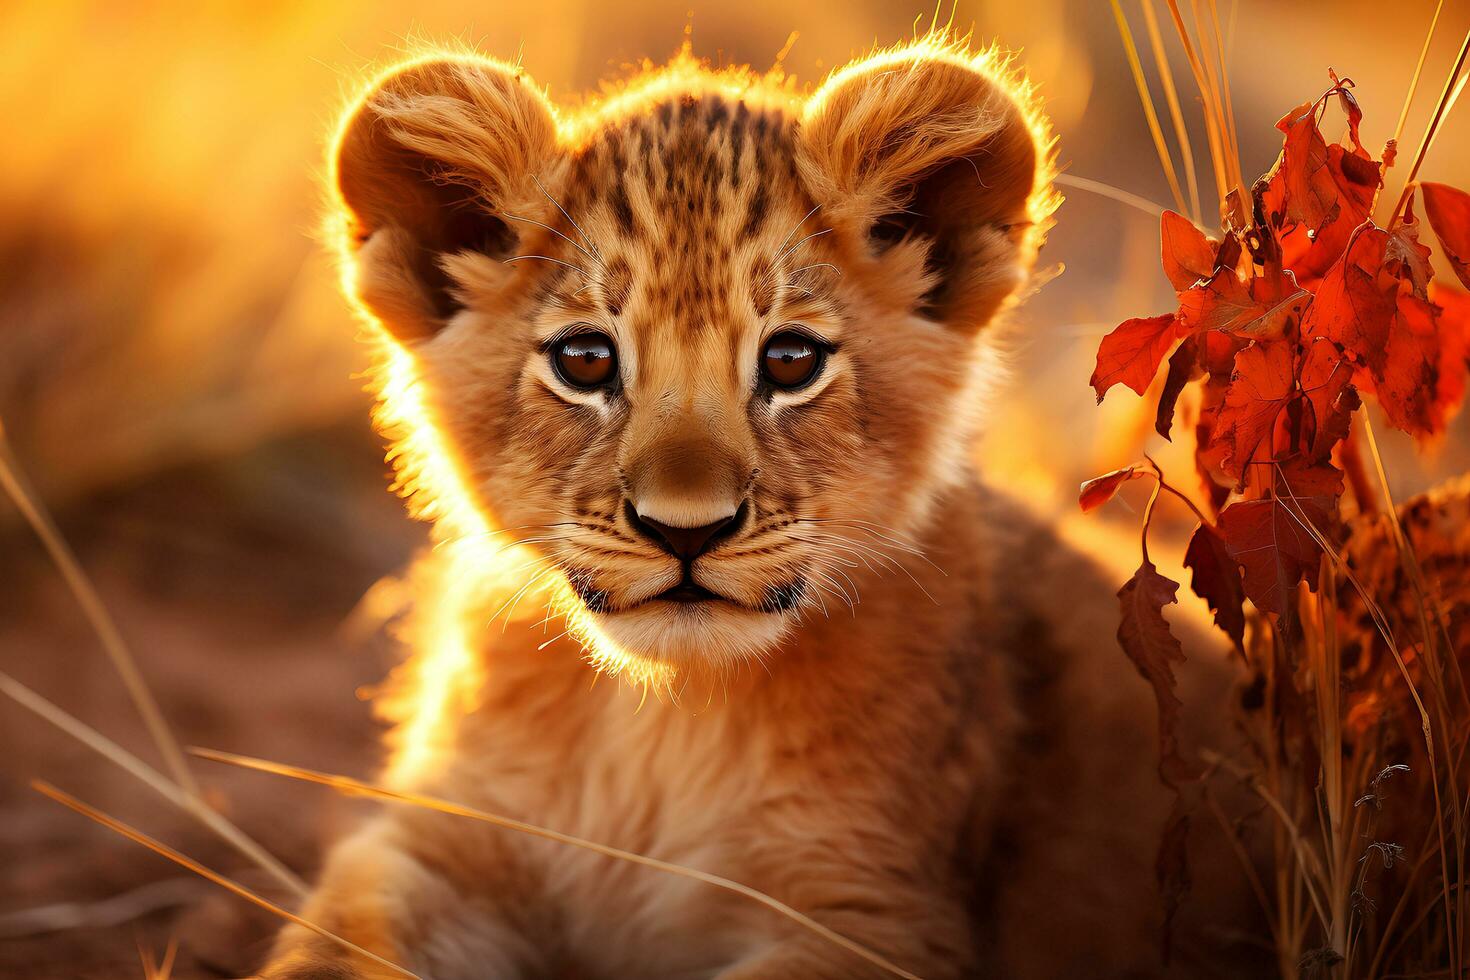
263 37 1258 980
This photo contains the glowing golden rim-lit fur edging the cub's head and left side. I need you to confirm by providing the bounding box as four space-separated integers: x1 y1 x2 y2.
326 29 1060 785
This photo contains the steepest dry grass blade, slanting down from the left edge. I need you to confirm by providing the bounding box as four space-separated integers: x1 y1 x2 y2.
0 428 198 796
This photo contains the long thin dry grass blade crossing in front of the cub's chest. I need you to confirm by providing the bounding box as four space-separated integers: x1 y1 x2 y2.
190 748 919 980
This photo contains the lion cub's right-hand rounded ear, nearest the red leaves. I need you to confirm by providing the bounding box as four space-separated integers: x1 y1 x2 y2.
798 51 1050 329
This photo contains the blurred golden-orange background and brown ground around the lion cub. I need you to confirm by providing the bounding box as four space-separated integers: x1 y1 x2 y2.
0 0 1470 977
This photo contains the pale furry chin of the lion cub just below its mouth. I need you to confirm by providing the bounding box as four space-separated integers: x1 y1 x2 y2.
591 601 792 667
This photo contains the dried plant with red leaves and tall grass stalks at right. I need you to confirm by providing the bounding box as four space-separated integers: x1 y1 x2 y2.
1080 0 1470 977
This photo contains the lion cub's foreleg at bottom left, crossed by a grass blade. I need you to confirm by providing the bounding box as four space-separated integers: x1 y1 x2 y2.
260 815 547 980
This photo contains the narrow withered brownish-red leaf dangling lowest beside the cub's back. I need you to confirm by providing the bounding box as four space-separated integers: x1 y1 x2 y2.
1117 558 1195 786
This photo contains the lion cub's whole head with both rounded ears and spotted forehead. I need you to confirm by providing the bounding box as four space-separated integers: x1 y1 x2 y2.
338 51 1039 661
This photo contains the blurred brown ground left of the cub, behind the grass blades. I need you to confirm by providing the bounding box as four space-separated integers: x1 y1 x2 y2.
0 426 422 980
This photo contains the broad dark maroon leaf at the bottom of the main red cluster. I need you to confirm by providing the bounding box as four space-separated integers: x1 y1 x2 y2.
1220 498 1327 616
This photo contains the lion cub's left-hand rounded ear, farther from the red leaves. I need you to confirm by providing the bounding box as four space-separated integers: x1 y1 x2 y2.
335 59 557 339
